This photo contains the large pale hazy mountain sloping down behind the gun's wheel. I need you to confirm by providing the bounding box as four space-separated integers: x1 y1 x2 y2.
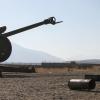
5 44 64 63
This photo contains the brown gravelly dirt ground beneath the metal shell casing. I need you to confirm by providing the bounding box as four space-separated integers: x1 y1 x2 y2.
0 73 100 100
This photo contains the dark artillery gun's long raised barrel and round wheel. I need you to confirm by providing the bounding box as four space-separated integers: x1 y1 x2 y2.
0 17 62 62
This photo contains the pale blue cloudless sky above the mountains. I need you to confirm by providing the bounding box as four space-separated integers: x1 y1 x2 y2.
0 0 100 60
